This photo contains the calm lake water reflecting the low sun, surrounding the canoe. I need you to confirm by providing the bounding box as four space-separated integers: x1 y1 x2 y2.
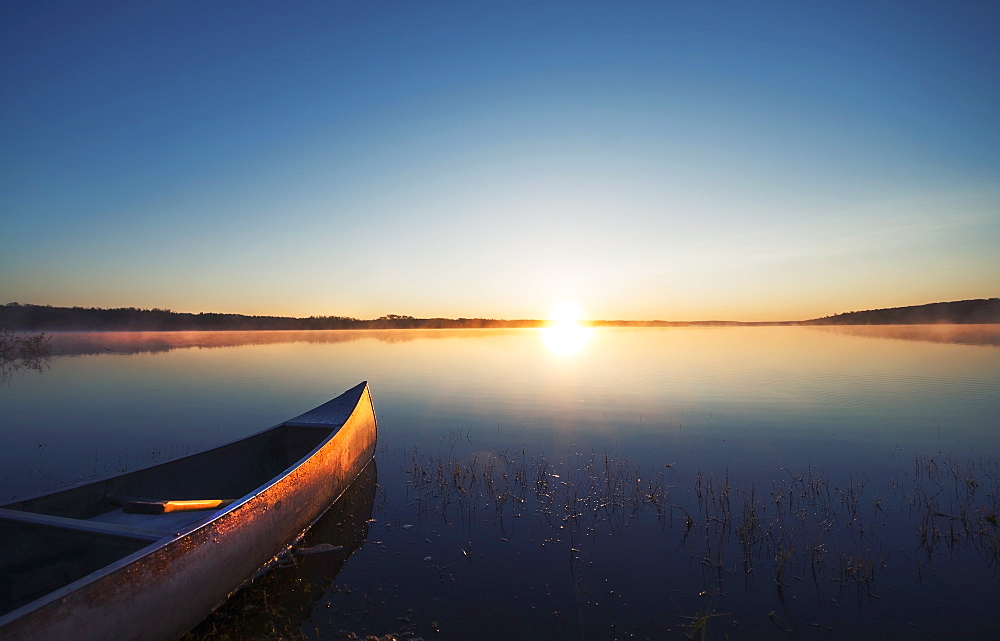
0 326 1000 639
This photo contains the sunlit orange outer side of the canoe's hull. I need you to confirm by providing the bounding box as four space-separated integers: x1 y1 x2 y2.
0 384 376 641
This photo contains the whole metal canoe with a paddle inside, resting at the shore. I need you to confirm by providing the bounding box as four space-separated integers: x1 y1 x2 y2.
0 383 377 641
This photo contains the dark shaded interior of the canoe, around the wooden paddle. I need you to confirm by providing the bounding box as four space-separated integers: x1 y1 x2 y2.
0 425 339 616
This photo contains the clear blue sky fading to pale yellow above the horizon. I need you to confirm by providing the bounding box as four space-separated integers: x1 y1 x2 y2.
0 0 1000 320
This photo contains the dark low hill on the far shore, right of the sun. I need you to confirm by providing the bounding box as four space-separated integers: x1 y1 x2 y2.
806 298 1000 325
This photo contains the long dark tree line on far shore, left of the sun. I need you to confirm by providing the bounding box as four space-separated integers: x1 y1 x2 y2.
0 303 544 331
